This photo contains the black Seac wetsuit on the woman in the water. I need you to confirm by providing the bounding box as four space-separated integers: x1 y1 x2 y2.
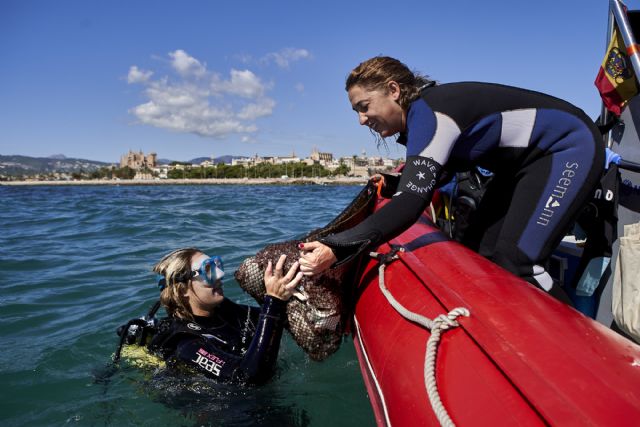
149 295 286 384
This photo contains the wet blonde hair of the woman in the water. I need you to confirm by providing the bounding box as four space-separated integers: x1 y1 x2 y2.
153 248 202 320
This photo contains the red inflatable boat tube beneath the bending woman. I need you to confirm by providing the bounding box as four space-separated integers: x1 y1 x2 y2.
353 201 640 427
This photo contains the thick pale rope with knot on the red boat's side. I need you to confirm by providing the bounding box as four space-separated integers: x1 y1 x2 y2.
370 246 469 427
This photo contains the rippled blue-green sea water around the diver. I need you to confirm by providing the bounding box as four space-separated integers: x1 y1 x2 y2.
0 185 375 427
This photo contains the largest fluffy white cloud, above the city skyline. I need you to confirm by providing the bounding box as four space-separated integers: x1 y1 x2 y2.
128 50 275 138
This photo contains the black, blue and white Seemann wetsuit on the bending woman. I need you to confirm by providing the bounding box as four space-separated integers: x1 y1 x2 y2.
322 82 604 290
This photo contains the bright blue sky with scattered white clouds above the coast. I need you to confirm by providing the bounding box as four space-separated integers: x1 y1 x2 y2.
0 0 640 162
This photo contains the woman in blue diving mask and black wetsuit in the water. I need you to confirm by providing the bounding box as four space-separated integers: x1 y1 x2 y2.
148 248 302 384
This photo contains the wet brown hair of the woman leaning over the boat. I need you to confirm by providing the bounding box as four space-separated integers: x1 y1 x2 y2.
345 56 433 111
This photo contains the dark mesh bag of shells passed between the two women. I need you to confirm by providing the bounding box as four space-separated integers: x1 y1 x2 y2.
235 183 376 360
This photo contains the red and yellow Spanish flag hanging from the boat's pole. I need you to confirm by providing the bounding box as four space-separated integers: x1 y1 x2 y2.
595 24 638 116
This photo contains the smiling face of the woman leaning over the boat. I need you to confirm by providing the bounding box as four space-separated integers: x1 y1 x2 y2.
348 81 405 138
